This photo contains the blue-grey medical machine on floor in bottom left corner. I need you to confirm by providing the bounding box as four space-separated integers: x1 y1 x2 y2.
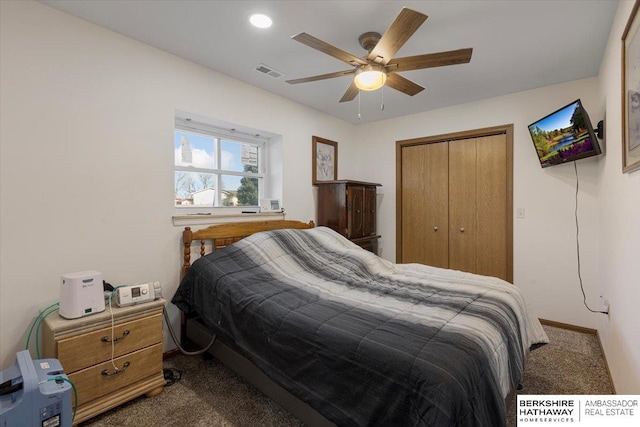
0 350 73 427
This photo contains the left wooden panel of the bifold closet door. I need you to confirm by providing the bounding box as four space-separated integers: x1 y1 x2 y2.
398 142 449 268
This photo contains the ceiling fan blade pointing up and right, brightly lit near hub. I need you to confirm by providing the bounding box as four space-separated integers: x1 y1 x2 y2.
367 7 428 65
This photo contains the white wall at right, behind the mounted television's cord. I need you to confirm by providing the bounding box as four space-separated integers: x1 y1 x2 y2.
598 1 640 394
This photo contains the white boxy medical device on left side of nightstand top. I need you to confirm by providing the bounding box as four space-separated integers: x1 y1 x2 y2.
59 270 105 319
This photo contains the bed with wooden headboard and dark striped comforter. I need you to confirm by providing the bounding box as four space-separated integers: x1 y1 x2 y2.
172 221 548 427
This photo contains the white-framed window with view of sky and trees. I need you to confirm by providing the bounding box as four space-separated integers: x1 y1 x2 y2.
173 118 266 208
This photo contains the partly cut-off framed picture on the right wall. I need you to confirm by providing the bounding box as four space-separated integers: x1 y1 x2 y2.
622 0 640 173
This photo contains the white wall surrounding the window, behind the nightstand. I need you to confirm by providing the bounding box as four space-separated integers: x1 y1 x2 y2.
0 1 353 369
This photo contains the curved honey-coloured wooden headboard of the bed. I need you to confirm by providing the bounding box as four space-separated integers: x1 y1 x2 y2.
181 220 315 277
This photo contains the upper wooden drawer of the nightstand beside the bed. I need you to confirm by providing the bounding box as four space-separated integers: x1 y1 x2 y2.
57 314 162 374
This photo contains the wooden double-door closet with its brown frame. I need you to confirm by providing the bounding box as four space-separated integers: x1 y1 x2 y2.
396 125 513 282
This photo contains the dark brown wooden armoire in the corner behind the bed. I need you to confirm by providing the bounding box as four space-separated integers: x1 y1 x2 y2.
316 180 380 254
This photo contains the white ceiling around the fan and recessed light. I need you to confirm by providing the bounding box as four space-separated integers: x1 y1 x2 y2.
41 0 618 123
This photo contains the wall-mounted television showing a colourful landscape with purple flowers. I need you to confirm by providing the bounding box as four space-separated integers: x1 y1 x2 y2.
529 99 602 168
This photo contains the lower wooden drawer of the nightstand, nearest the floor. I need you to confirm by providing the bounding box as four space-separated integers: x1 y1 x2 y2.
68 343 162 405
